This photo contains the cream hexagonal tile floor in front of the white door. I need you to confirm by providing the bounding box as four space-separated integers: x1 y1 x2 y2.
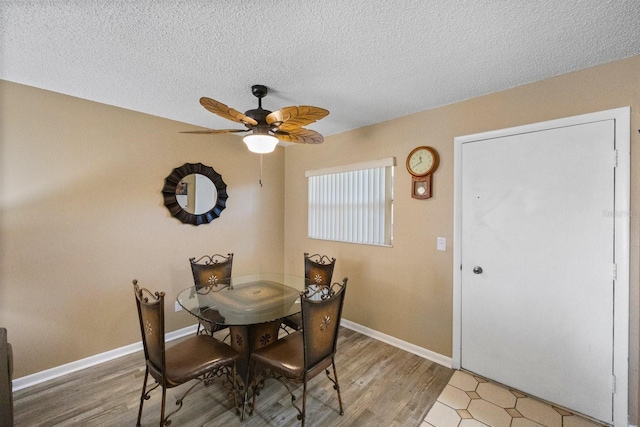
421 371 603 427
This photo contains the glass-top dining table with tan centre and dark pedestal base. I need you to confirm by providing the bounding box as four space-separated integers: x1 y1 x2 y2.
177 273 305 418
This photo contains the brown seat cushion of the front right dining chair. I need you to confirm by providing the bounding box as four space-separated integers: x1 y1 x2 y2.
251 331 331 380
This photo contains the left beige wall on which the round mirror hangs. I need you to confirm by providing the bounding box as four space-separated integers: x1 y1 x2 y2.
0 81 284 378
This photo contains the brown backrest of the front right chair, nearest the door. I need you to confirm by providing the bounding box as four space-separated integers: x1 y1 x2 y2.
301 277 347 371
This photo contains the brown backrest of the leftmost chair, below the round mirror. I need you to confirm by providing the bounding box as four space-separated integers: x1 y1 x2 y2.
133 280 165 376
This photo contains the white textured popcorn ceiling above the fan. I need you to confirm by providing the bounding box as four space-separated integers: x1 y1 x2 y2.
0 0 640 138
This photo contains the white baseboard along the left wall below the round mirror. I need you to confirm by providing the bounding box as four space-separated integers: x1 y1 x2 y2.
13 325 198 392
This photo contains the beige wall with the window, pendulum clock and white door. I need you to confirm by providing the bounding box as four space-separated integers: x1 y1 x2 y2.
285 57 640 424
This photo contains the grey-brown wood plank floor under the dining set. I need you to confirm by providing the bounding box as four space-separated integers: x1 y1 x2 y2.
14 328 453 427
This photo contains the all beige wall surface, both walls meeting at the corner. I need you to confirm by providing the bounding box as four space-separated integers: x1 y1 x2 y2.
0 57 640 424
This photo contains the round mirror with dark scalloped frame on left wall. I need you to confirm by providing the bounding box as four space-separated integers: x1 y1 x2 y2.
162 163 229 225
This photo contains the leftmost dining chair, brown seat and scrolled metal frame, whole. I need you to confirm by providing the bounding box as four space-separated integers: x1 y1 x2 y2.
133 280 239 426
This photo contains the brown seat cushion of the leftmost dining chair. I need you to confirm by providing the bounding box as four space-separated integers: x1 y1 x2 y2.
165 335 238 387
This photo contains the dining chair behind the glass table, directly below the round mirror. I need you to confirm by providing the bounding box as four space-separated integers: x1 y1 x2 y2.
189 253 233 335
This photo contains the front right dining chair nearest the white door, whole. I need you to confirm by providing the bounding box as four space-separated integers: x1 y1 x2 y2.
249 277 347 426
